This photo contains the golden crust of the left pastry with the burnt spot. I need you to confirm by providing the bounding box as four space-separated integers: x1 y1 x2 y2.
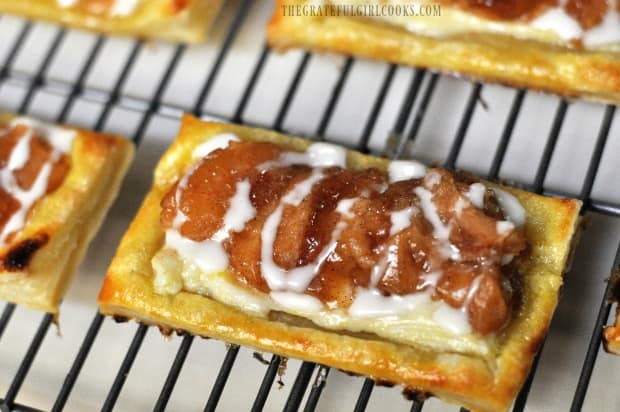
0 115 134 314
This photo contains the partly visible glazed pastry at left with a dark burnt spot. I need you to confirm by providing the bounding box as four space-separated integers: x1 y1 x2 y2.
0 115 134 314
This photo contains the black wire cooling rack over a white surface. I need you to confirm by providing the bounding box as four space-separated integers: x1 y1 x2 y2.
0 0 620 412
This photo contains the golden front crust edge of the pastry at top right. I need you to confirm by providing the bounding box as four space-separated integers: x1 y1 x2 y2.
267 0 620 104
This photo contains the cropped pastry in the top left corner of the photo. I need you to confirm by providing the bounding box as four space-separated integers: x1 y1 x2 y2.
0 0 223 43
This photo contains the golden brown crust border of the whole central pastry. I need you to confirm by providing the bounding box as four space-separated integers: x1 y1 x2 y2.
99 116 581 411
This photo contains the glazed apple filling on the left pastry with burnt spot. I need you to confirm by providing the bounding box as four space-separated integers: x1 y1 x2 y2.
0 118 74 247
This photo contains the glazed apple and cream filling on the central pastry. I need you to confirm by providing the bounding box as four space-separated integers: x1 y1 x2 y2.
152 135 527 355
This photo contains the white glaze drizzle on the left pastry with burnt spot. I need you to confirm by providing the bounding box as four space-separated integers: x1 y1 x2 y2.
0 117 76 246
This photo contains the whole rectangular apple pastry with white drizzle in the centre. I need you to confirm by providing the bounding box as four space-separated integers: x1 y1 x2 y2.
99 116 581 411
